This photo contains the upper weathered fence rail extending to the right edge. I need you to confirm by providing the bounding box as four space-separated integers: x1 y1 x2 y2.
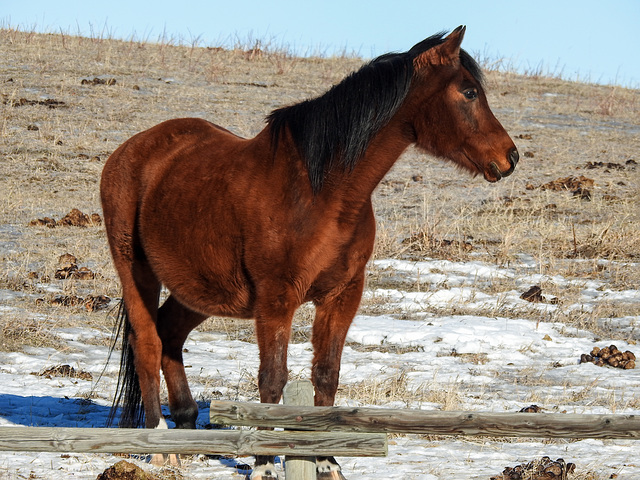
210 401 640 439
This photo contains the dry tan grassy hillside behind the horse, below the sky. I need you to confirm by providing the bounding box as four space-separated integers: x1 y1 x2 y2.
0 29 640 349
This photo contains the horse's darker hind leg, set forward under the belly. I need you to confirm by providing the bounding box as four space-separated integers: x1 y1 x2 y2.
158 296 207 428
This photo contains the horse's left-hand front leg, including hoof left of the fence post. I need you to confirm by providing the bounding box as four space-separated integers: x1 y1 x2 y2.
250 296 298 480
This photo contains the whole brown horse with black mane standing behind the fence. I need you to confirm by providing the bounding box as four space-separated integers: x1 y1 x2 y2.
101 27 518 480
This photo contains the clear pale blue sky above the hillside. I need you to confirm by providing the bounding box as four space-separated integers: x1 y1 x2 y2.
5 0 640 88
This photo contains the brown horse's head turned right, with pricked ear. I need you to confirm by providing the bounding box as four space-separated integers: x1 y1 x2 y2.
407 27 519 182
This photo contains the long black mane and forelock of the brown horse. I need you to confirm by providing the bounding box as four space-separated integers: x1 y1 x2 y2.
267 32 482 192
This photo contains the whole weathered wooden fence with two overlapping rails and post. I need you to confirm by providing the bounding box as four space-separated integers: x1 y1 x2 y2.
0 382 640 480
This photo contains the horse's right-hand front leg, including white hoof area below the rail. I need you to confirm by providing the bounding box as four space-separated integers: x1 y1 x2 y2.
311 268 364 480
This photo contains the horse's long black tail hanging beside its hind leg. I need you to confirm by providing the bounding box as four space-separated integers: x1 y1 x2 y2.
107 300 144 428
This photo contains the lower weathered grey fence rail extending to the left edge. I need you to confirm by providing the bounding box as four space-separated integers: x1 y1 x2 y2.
0 427 387 457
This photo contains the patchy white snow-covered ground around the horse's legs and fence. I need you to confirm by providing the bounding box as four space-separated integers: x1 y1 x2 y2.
0 258 640 480
